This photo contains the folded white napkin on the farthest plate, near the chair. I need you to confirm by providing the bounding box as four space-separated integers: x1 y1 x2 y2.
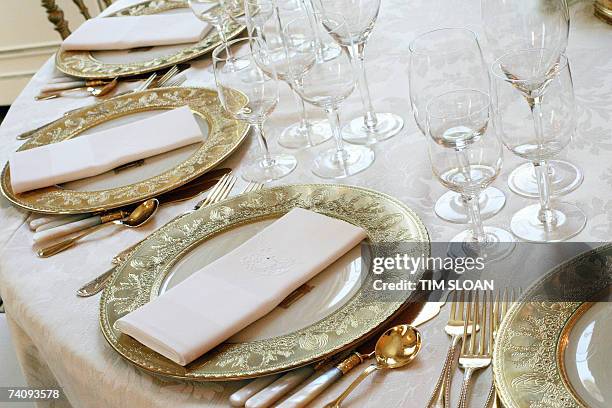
62 13 211 51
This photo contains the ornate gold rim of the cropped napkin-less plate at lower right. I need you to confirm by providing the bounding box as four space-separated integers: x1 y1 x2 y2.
493 244 612 408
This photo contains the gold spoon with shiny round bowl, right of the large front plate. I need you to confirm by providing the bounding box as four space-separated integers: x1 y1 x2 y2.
324 324 421 408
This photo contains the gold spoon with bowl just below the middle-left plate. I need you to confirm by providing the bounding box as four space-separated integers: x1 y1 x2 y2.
37 198 159 258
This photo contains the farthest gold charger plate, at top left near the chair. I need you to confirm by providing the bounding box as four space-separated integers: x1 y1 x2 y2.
55 0 244 78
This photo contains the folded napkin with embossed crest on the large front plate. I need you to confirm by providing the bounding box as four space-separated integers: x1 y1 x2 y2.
116 208 366 365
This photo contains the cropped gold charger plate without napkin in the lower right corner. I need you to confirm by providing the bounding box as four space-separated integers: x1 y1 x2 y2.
493 244 612 408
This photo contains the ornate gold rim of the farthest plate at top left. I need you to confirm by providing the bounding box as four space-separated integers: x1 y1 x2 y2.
55 0 244 78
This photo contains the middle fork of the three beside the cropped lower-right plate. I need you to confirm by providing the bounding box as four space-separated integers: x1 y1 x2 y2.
459 292 494 408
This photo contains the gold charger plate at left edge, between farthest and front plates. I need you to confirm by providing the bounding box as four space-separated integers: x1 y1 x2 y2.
0 87 248 214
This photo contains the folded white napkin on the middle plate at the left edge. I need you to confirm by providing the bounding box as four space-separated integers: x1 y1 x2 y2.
9 106 203 193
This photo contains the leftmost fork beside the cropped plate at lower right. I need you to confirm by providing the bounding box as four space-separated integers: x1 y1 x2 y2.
426 291 472 408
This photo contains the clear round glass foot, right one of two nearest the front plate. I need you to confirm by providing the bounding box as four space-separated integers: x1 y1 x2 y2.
312 146 374 179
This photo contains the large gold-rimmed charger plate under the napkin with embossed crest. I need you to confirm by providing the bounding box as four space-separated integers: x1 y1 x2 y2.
100 184 430 381
